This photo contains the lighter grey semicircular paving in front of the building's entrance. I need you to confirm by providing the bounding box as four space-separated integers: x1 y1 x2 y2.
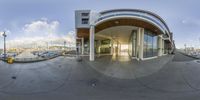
85 55 173 79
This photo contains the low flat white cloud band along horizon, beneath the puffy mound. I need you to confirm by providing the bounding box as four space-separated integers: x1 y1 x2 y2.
7 31 75 48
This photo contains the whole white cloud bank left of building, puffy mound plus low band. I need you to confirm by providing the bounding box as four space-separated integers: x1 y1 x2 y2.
7 18 75 48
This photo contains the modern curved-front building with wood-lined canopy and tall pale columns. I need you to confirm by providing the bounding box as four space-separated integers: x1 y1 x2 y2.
75 9 174 61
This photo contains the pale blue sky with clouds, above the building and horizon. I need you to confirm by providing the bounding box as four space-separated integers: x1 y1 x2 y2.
0 0 200 48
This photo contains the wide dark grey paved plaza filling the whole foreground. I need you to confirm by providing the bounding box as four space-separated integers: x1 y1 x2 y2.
0 53 200 100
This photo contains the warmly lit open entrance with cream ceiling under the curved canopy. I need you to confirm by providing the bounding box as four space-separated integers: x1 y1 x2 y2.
95 26 138 60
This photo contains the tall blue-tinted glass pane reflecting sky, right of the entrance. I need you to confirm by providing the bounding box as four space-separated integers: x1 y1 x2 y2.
143 30 158 58
